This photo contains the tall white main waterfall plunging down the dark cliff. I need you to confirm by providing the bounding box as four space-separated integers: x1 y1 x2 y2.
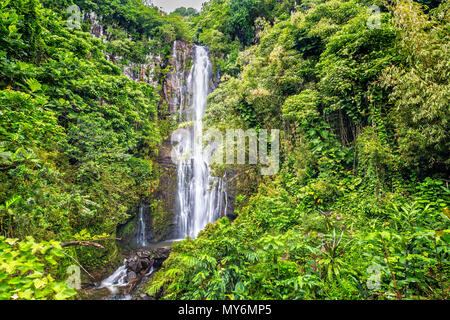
174 46 226 238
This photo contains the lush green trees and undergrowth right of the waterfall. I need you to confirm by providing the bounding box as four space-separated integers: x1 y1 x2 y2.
149 0 450 299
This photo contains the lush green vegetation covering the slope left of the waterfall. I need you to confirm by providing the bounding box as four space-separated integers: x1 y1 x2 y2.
0 0 185 298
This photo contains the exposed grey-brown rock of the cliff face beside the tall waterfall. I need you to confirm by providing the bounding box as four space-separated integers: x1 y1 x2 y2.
83 12 234 242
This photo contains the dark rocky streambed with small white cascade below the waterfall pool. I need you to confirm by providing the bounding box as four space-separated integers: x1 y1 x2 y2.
82 246 171 300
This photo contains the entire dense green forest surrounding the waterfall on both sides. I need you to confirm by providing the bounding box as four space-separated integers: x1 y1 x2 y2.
0 0 450 300
